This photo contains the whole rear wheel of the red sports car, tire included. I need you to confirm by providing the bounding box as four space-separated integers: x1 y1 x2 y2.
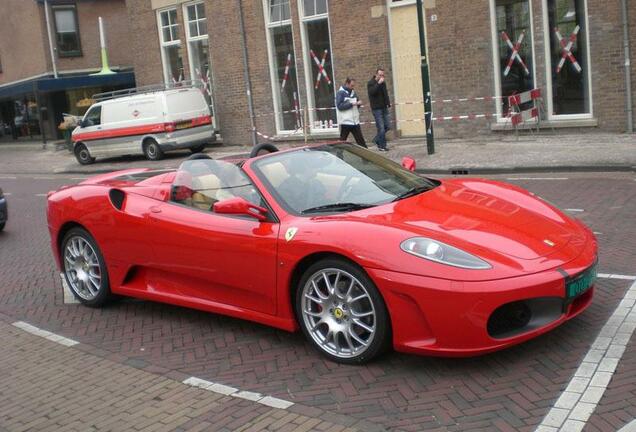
61 228 111 307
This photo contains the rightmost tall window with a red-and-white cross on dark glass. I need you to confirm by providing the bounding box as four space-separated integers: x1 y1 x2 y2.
544 0 591 116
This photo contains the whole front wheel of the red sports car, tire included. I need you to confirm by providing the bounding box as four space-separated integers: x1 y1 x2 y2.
295 259 391 364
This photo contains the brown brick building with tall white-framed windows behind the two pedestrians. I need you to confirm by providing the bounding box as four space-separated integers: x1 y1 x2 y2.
121 0 636 144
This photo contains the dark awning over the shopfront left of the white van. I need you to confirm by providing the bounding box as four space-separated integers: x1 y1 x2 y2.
0 72 135 99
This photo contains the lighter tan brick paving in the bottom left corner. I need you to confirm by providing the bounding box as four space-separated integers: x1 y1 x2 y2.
0 321 358 432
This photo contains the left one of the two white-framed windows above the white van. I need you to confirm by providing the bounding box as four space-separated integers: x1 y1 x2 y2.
158 9 184 83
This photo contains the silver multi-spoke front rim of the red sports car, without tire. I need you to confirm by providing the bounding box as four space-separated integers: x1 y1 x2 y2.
301 268 377 358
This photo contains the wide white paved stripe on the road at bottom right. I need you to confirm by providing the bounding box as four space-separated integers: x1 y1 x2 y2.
536 282 636 432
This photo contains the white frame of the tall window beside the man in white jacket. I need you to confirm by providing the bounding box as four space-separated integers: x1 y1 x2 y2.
298 0 339 135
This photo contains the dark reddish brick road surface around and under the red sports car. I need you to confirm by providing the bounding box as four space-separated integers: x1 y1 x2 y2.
0 170 636 431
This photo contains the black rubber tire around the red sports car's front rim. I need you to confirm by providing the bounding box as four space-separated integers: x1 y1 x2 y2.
294 258 391 365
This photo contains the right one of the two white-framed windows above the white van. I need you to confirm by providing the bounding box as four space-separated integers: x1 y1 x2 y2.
184 3 216 127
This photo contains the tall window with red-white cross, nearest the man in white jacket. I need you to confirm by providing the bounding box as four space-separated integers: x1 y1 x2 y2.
300 0 338 129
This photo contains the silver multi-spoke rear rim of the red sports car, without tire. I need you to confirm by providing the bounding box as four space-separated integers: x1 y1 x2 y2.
64 236 102 301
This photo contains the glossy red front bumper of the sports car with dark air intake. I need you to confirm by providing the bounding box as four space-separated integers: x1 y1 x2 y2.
366 236 597 357
